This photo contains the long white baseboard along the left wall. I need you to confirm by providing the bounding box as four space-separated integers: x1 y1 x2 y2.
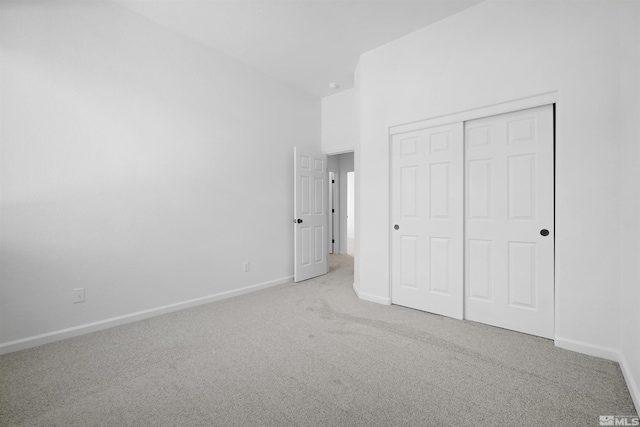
0 276 293 354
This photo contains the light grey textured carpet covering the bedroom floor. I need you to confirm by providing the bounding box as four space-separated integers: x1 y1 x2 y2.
0 256 635 426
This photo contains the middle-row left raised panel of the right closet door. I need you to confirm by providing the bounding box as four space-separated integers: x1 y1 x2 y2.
467 159 492 219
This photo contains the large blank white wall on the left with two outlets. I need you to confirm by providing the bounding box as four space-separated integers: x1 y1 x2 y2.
0 1 320 351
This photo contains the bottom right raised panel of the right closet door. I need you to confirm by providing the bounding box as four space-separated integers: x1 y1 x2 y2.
509 242 536 309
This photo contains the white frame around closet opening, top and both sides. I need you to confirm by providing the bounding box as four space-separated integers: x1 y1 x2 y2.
388 91 559 338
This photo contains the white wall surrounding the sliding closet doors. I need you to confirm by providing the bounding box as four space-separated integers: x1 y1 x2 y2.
355 1 640 408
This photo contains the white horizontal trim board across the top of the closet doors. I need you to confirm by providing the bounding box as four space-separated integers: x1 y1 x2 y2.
389 91 559 135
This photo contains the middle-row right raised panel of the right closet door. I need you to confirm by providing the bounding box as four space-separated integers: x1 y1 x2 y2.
508 154 536 220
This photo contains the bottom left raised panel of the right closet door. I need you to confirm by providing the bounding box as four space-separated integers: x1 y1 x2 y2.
467 239 493 302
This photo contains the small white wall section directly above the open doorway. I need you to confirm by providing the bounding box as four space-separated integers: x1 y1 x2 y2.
322 89 357 154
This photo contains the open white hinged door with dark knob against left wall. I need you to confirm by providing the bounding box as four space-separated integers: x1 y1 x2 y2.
293 148 329 282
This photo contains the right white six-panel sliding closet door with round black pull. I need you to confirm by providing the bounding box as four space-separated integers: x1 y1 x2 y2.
465 105 554 338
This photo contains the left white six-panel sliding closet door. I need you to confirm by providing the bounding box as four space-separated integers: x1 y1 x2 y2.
391 123 464 319
